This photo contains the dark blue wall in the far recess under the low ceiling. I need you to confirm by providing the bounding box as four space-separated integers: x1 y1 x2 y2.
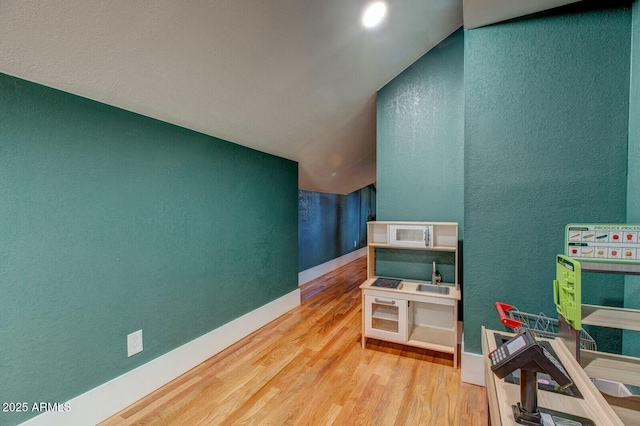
298 185 376 272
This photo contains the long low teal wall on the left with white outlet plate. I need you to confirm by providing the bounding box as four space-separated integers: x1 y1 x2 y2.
0 74 298 425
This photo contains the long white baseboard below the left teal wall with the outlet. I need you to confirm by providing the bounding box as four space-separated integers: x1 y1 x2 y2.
23 289 300 426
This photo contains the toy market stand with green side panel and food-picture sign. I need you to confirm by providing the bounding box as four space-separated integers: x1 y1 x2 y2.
554 224 640 425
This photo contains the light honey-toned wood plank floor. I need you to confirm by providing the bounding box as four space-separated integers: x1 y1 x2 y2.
102 258 487 426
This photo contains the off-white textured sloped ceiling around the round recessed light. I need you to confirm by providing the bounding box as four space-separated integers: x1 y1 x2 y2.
0 0 575 194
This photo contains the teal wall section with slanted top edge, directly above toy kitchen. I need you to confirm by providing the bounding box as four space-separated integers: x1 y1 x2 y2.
376 29 464 231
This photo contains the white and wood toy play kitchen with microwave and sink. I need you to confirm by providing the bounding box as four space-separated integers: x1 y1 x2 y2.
360 222 460 368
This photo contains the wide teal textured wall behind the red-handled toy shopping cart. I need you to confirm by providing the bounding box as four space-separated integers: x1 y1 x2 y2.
464 8 631 353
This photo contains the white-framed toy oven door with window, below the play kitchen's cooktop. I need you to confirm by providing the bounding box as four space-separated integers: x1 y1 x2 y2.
364 294 408 343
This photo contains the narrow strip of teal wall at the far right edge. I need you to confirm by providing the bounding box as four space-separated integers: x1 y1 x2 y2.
622 2 640 357
